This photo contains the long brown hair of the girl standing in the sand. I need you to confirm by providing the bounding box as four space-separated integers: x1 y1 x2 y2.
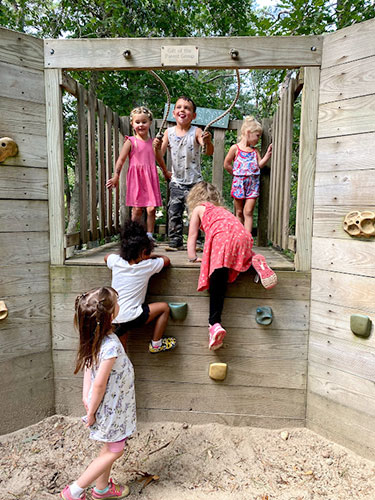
74 286 117 374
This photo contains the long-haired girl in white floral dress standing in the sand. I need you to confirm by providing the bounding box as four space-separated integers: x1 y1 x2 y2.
60 287 136 500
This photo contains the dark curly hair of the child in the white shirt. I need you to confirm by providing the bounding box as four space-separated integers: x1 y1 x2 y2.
120 220 154 262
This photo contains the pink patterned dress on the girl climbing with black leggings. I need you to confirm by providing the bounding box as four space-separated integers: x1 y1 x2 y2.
198 203 253 292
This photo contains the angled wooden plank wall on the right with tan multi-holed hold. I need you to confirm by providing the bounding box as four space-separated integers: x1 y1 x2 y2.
307 20 375 459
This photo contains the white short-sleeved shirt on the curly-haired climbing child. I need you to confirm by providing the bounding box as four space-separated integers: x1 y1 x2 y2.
107 253 164 324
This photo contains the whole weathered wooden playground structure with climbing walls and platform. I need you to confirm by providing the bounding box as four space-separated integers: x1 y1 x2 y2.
0 20 375 459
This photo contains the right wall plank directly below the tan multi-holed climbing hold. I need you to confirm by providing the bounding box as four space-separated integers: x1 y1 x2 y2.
312 237 375 278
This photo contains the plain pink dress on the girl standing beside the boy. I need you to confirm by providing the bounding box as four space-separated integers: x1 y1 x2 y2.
124 136 162 207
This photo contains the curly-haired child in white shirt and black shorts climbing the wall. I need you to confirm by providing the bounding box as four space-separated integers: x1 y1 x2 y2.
104 221 176 353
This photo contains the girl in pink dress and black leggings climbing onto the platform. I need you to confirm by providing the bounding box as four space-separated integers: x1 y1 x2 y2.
187 182 277 350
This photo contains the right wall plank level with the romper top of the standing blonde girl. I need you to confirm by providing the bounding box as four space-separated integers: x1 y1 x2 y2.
316 133 375 174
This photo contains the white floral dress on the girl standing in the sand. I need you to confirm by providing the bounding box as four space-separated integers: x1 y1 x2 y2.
89 333 136 443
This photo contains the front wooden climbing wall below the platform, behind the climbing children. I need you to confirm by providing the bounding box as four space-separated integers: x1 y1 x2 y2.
51 266 310 428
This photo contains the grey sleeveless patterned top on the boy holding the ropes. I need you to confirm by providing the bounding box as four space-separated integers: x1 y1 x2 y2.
168 125 203 184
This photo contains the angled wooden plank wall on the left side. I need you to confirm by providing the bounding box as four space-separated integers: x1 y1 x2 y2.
0 28 54 434
